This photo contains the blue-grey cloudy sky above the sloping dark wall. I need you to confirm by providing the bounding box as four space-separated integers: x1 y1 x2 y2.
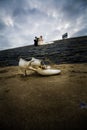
0 0 87 50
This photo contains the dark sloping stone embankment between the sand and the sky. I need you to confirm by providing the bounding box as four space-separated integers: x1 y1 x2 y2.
0 36 87 66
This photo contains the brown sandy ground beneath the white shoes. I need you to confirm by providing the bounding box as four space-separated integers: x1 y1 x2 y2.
0 64 87 130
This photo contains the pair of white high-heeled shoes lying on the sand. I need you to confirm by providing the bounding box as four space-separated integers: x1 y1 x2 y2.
19 57 61 75
